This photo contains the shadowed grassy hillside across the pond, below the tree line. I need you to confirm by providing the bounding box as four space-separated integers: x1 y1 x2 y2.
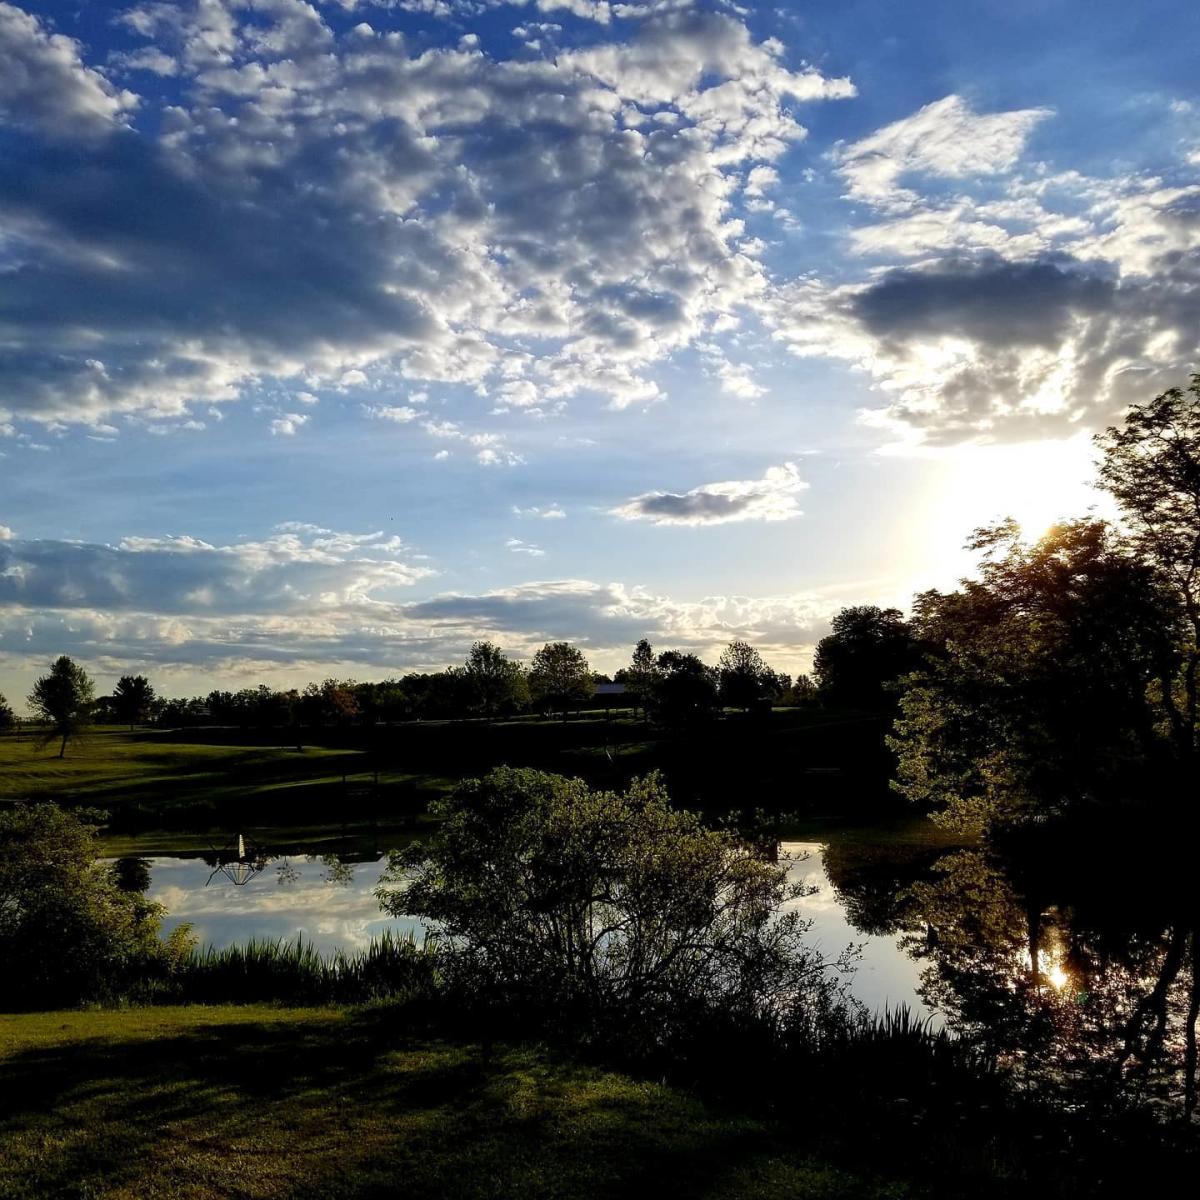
0 709 902 832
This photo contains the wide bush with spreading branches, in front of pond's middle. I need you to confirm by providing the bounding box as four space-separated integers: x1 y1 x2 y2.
379 768 847 1057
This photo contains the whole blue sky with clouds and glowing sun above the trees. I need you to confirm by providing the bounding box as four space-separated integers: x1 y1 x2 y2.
0 0 1200 700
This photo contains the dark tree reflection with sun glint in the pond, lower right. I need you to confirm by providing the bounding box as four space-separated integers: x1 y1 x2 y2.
824 830 1200 1114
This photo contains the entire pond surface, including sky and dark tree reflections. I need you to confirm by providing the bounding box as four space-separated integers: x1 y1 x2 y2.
121 828 1200 1097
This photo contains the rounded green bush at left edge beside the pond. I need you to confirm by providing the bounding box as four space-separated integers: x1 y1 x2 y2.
0 804 188 1010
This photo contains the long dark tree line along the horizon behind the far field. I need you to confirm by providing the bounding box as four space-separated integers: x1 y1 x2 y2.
0 633 883 756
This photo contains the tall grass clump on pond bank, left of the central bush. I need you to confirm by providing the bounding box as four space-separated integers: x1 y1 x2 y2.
172 931 438 1004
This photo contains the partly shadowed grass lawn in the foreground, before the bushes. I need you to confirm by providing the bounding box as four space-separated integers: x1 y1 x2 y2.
0 1007 910 1200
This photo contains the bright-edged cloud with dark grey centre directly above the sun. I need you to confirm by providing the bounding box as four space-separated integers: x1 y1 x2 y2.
769 96 1200 444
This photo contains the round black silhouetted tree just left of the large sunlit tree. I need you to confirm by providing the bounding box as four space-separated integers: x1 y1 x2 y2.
812 605 918 712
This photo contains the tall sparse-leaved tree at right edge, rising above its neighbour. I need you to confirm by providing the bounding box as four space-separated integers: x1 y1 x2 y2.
1097 374 1200 758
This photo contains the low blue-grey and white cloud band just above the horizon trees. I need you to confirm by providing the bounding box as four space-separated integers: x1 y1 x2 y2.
0 522 830 682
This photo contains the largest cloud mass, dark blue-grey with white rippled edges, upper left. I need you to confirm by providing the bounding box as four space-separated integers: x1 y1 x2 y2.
0 0 853 432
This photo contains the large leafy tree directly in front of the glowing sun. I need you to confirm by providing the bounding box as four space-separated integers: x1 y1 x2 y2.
890 521 1180 829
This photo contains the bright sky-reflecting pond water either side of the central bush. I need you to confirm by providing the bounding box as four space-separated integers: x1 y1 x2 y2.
140 841 928 1014
